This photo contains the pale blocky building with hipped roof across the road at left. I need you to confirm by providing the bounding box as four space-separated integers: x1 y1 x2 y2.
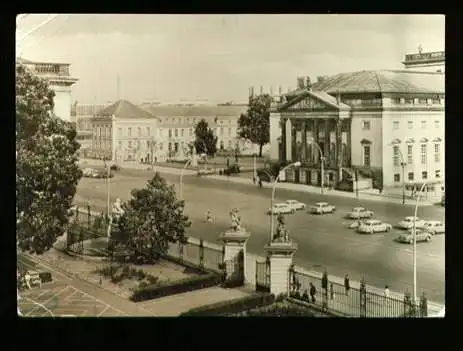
90 100 163 163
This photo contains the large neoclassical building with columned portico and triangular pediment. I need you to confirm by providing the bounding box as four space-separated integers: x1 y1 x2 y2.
270 70 445 187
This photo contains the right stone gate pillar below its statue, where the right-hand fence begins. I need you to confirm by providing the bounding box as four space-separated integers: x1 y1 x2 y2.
264 241 297 296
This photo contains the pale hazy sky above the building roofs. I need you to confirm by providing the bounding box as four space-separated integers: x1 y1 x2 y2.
16 14 445 103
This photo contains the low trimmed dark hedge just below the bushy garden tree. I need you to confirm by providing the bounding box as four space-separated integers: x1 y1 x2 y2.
130 273 223 302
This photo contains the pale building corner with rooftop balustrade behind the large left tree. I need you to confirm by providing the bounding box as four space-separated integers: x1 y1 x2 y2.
17 58 78 122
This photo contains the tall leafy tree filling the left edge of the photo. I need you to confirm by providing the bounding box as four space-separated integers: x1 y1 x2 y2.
16 65 82 254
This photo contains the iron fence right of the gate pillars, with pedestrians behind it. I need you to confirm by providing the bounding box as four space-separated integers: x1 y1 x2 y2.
290 267 427 318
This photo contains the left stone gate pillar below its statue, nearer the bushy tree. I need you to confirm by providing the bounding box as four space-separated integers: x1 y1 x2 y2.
219 230 251 282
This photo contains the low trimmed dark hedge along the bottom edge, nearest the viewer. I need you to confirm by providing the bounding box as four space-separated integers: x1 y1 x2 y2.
180 294 275 317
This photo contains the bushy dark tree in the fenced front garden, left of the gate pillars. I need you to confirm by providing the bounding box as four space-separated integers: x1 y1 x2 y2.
114 172 191 260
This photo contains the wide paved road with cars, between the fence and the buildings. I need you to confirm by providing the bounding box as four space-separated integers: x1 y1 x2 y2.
76 170 445 302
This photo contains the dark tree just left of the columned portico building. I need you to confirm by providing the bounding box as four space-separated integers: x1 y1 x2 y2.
238 94 272 157
